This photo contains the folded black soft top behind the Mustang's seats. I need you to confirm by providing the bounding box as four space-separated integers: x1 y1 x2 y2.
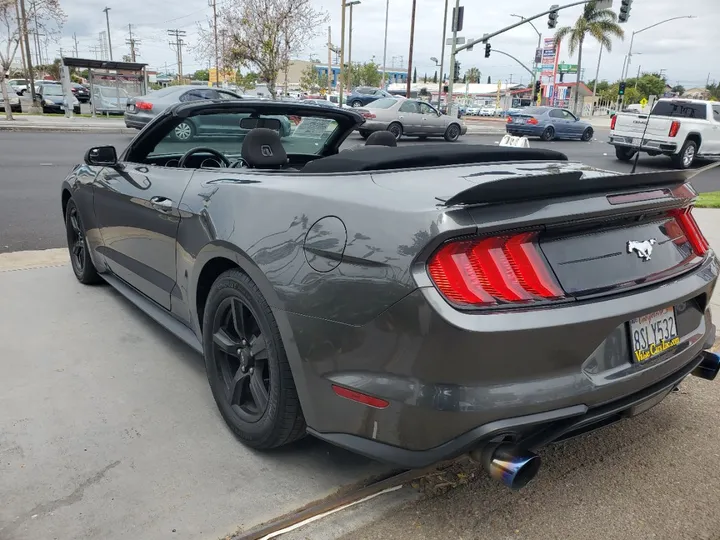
301 144 568 174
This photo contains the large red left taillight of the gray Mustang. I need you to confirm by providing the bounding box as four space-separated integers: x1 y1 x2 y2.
428 232 564 307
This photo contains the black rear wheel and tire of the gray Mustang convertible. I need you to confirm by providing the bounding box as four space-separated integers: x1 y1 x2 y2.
203 269 306 449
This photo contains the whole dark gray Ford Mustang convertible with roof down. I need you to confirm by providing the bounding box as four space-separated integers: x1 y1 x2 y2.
61 100 720 488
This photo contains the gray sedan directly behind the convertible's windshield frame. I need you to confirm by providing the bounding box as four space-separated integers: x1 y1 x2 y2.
124 85 243 131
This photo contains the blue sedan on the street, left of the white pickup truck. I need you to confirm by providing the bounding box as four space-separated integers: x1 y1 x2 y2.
505 107 594 141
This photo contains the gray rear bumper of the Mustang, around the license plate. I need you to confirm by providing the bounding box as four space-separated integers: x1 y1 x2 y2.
284 255 720 467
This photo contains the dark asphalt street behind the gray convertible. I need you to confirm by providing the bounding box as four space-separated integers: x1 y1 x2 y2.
0 130 720 253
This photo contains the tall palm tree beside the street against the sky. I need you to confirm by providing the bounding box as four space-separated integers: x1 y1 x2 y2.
555 2 625 114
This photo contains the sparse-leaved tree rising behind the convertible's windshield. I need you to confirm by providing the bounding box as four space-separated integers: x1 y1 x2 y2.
193 0 329 98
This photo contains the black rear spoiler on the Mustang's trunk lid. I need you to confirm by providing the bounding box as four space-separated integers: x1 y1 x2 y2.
437 162 720 206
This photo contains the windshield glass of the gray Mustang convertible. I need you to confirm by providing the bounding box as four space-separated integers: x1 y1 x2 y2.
148 113 339 160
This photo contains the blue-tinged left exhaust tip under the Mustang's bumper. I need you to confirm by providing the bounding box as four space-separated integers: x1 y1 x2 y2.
470 443 540 489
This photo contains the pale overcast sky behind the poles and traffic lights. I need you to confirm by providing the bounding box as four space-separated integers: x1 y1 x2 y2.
50 0 720 87
